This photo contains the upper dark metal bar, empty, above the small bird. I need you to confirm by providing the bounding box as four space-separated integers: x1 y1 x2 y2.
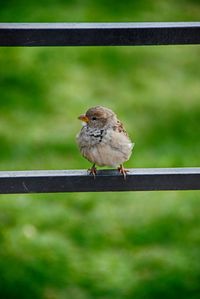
0 22 200 47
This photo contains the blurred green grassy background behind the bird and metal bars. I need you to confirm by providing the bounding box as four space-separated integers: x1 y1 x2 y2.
0 0 200 299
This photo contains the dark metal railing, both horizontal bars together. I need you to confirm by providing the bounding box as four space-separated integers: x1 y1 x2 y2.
0 22 200 194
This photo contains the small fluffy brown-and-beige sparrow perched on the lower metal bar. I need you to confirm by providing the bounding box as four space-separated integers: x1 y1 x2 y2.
76 106 134 179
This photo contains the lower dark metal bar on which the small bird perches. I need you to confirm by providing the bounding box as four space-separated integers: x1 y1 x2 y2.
0 168 200 194
